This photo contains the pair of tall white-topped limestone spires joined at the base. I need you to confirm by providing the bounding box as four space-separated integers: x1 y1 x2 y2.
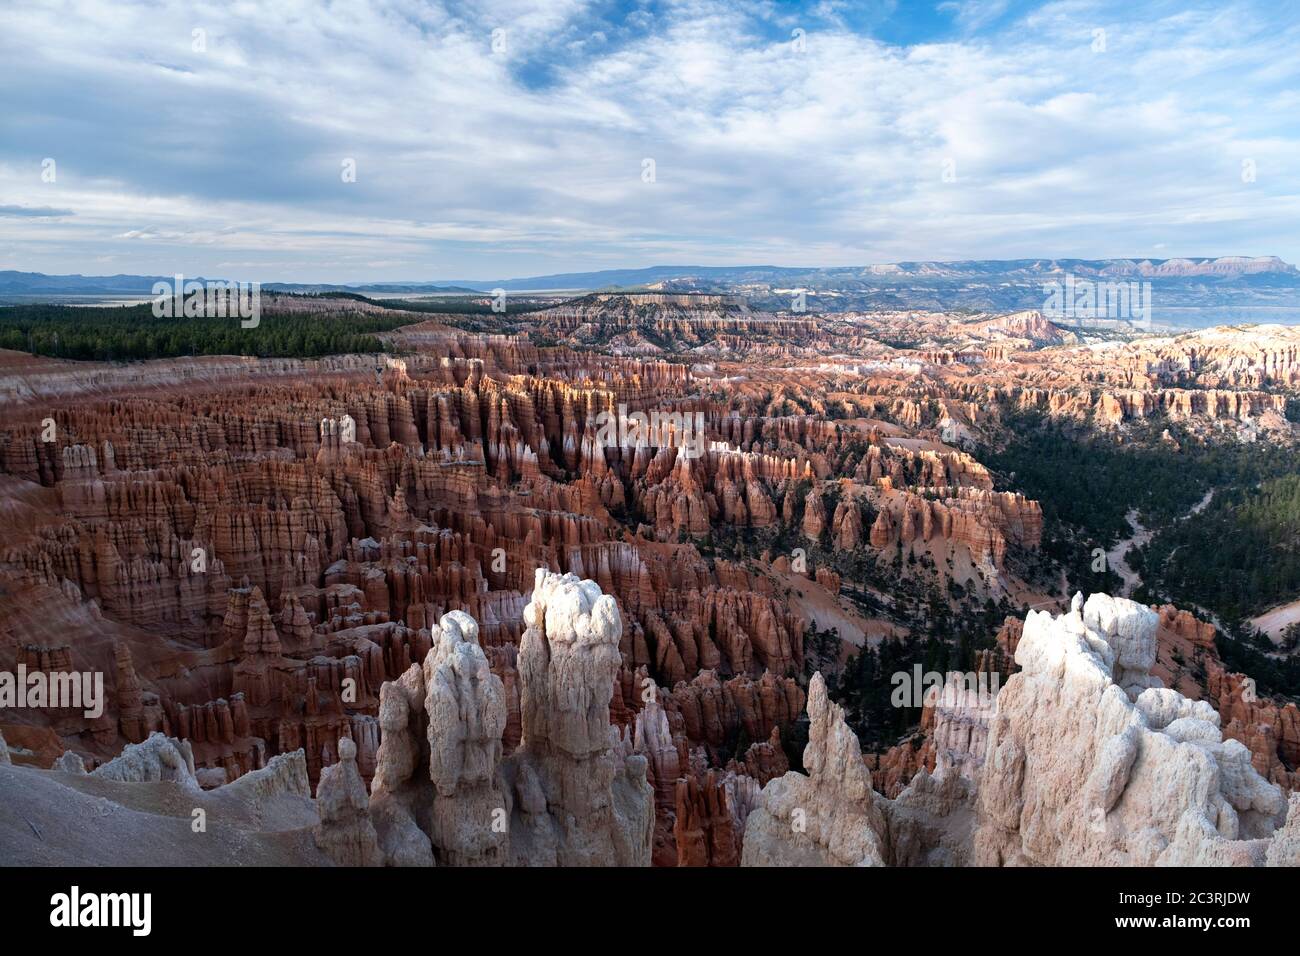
369 570 654 866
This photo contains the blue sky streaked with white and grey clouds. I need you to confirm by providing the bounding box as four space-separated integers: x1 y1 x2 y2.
0 0 1300 282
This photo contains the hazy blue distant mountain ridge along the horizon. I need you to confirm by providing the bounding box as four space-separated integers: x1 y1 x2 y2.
0 256 1300 328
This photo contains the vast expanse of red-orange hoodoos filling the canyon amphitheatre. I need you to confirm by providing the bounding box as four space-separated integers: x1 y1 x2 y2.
0 297 1300 862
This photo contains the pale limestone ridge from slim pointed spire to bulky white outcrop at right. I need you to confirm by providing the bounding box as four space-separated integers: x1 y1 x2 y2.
742 594 1300 866
